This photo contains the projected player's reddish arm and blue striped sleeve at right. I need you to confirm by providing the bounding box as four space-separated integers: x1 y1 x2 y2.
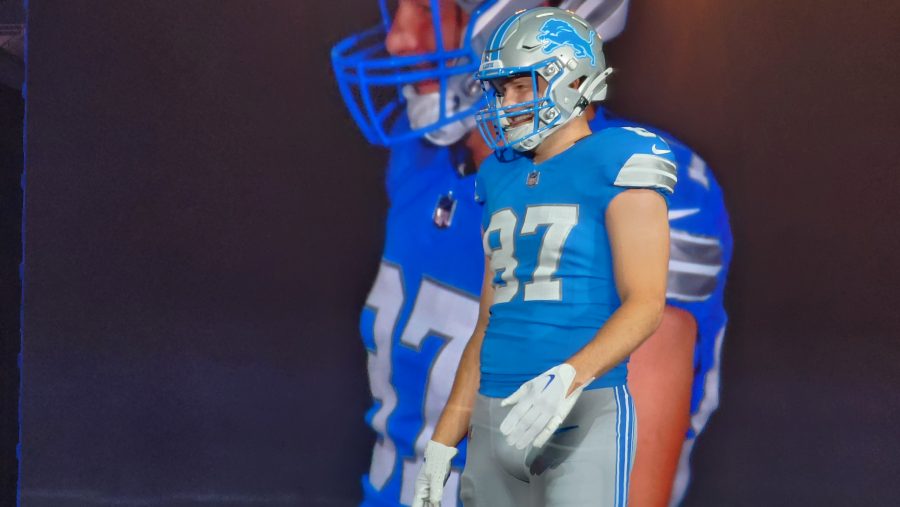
628 155 730 507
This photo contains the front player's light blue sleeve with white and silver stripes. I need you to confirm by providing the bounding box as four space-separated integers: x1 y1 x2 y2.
609 127 678 197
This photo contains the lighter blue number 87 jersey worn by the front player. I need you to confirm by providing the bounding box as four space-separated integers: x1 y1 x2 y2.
476 127 676 397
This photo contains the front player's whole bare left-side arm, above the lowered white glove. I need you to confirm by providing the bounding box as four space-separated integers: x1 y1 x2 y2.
431 259 494 447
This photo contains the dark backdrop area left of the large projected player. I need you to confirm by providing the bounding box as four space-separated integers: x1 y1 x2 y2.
21 0 386 506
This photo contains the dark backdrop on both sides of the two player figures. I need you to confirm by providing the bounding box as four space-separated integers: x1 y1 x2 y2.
12 0 900 506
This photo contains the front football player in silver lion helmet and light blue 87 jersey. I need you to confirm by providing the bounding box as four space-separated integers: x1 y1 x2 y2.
422 7 677 507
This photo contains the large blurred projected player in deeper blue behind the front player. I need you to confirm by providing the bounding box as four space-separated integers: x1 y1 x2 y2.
332 0 731 507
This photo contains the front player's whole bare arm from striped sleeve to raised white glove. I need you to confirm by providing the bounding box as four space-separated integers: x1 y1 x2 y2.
566 189 669 388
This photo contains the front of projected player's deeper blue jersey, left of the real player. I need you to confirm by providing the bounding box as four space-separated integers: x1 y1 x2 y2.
360 128 484 506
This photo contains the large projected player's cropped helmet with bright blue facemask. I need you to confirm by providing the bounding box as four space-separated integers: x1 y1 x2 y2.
331 0 628 146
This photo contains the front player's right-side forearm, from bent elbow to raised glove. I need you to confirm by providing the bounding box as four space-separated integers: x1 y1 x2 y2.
566 296 666 387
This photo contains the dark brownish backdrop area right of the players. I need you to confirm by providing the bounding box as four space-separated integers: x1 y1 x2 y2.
596 0 900 505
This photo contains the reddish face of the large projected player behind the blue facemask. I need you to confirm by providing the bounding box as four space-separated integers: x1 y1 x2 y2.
385 0 468 93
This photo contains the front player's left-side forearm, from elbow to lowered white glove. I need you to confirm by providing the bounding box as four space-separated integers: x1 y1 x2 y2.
431 329 484 447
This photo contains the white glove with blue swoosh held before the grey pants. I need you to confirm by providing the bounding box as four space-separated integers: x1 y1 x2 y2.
500 363 594 449
